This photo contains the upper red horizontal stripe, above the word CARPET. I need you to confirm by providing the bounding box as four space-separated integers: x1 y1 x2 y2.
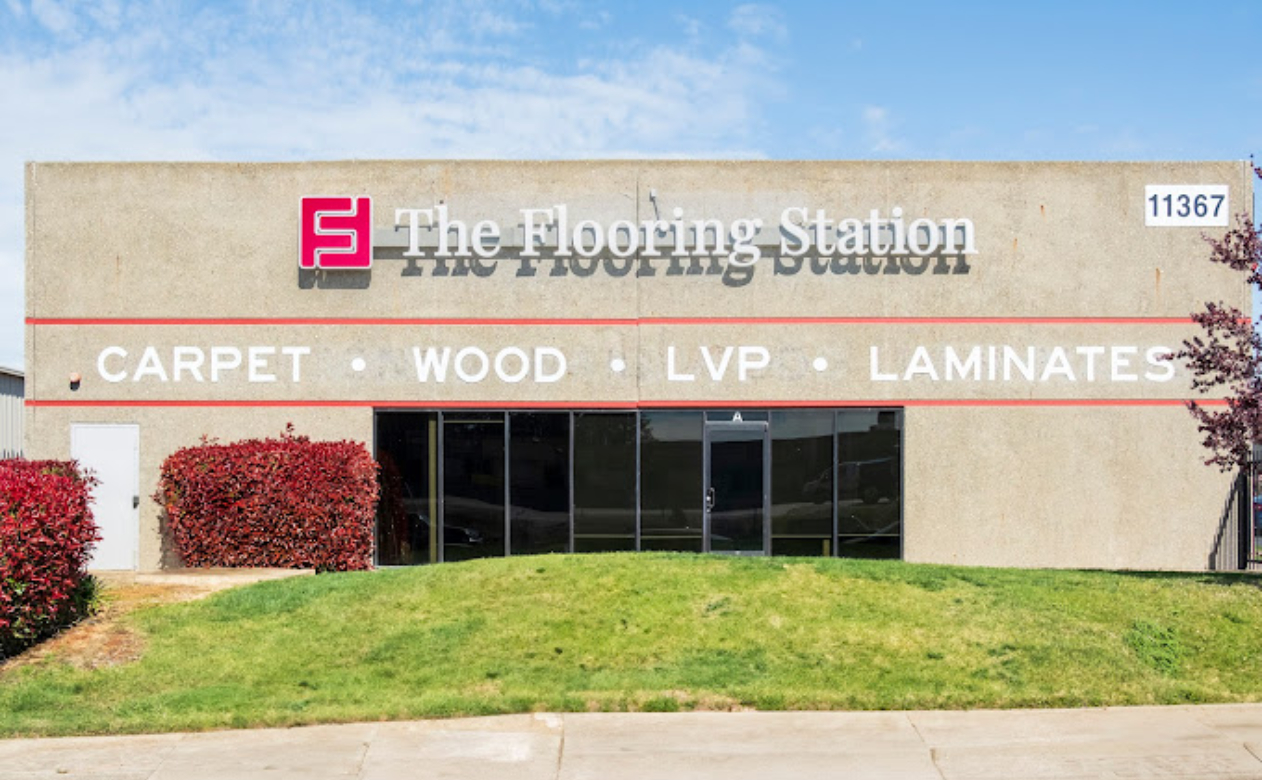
27 317 1191 326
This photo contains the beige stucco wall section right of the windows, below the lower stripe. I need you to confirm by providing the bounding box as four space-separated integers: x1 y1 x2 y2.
904 406 1232 569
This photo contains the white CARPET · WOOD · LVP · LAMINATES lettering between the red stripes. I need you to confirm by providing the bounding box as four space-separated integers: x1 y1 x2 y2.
86 343 1175 385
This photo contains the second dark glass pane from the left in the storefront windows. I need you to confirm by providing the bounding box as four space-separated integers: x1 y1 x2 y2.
443 414 504 560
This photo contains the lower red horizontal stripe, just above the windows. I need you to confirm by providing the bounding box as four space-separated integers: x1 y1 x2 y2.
27 398 1227 410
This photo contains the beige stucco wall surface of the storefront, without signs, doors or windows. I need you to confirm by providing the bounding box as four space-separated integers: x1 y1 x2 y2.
27 162 1252 569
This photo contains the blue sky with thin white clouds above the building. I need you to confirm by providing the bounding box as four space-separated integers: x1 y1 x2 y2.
0 0 1262 367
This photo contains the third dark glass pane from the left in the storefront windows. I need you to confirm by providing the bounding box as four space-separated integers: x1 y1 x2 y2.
509 411 569 555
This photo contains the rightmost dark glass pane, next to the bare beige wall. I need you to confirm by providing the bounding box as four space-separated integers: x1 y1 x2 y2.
837 409 902 558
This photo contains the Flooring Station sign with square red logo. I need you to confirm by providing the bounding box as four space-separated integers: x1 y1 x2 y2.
299 197 977 275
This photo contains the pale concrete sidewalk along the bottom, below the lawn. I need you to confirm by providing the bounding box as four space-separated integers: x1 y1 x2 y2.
0 704 1262 780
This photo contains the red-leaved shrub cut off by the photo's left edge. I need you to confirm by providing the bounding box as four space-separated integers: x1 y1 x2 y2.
0 458 100 659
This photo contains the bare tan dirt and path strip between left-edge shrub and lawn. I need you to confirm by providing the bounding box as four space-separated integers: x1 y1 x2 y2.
0 577 228 675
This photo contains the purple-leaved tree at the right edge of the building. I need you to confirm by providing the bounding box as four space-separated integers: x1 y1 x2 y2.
1174 165 1262 471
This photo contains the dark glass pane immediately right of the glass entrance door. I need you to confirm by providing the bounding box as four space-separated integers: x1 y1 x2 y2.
771 409 834 555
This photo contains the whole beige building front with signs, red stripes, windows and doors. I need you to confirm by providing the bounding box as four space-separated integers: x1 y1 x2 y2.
19 160 1252 569
